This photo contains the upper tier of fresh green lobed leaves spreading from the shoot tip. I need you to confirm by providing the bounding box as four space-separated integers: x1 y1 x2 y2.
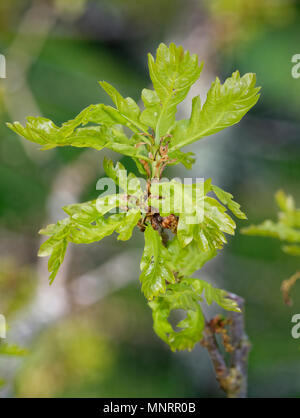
7 43 259 170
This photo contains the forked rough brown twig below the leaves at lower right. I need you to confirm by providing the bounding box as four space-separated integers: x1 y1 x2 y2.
201 293 251 398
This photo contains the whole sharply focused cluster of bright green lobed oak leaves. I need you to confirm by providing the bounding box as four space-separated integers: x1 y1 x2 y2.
8 44 259 350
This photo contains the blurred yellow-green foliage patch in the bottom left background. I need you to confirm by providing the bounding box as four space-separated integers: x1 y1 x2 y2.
16 317 115 397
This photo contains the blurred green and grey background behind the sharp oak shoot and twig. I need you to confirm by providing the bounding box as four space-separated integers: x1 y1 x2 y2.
0 0 300 397
